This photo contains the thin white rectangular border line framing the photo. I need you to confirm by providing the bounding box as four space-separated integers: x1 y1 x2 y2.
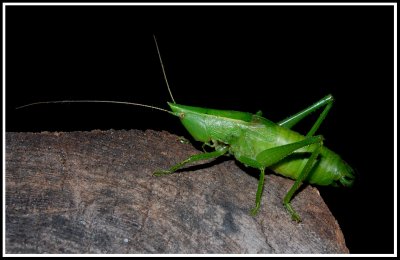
2 2 397 257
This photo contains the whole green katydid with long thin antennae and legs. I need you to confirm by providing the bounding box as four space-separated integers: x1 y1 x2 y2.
19 37 354 222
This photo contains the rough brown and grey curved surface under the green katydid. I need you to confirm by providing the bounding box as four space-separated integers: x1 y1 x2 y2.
6 130 348 254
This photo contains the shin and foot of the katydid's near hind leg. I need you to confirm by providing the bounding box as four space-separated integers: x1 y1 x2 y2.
283 141 322 222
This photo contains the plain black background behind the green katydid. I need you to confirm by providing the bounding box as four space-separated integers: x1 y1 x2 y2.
6 6 394 253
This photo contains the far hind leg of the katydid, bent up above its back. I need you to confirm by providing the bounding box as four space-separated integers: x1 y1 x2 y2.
278 95 334 136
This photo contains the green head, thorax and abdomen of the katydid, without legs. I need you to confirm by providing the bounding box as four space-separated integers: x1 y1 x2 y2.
168 100 352 186
